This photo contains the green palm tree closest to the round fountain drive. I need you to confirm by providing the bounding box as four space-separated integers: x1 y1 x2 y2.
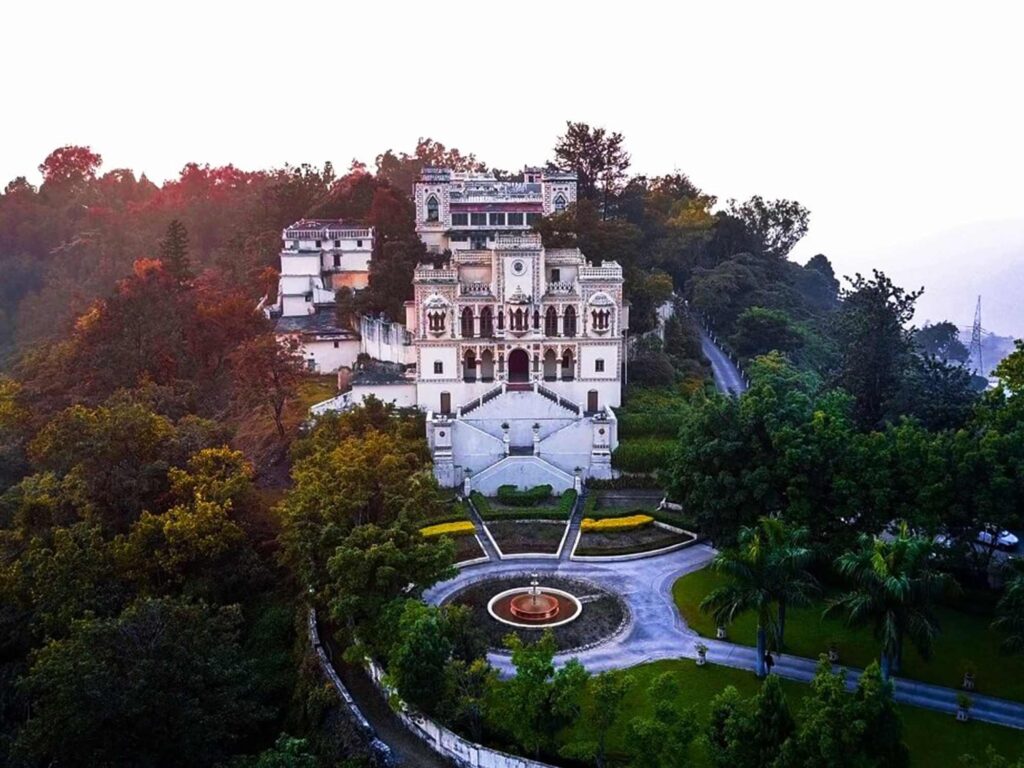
700 517 817 677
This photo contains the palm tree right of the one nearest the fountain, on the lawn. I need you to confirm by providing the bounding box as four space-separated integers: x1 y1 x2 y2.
825 523 950 680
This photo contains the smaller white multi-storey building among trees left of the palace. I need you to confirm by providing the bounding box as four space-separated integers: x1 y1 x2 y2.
268 219 374 373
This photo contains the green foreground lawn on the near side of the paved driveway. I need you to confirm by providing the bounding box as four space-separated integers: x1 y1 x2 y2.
563 659 1024 768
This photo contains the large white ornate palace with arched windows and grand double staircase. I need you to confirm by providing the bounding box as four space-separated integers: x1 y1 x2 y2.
296 168 629 494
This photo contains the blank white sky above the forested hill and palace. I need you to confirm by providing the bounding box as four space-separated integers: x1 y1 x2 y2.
6 0 1024 333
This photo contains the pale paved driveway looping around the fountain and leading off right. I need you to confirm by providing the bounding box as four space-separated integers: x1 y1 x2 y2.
424 545 1024 729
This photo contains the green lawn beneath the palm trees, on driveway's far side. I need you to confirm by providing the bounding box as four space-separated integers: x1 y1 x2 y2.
672 568 1024 700
